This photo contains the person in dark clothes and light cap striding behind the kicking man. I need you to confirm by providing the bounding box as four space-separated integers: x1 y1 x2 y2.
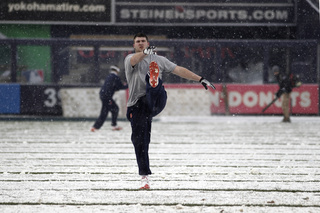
91 65 128 132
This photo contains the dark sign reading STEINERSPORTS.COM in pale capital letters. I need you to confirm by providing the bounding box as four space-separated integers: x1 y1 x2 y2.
115 0 296 26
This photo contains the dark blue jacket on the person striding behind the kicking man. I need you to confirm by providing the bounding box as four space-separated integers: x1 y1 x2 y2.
99 73 128 100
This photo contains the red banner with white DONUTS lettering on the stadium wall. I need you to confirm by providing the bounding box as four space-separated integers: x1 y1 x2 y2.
211 84 319 114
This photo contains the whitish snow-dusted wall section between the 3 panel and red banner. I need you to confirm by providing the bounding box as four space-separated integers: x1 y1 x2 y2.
60 86 210 118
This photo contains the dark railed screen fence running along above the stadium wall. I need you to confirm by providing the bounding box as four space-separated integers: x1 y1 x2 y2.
0 38 320 85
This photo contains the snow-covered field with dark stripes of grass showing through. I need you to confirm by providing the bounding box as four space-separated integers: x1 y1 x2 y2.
0 116 320 213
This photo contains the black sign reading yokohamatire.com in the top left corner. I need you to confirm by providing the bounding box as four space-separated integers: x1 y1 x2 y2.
0 0 111 24
